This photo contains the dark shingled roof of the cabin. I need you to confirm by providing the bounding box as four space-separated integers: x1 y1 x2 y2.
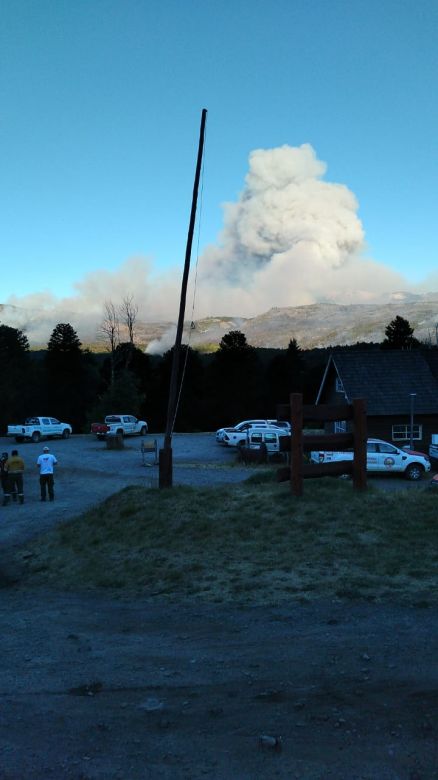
331 350 438 415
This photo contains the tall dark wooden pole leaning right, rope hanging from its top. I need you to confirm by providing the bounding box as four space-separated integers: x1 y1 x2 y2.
159 108 207 488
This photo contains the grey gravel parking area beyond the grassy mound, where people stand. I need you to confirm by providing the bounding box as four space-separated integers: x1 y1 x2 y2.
0 433 251 551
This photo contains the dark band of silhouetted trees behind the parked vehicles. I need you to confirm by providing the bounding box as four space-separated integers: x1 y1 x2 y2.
0 316 431 434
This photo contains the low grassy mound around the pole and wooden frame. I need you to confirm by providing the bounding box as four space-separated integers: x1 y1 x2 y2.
19 471 438 606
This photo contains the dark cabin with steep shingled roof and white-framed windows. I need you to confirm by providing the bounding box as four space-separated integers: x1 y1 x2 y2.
316 349 438 452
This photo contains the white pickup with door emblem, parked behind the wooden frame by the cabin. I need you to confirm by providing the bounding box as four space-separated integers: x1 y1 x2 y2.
310 439 430 480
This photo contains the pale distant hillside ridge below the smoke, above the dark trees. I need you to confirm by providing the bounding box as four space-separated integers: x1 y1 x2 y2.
0 293 438 352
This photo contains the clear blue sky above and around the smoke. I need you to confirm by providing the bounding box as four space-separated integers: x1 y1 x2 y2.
0 0 438 316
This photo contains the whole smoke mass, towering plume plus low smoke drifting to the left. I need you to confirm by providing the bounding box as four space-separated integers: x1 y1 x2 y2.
3 144 424 342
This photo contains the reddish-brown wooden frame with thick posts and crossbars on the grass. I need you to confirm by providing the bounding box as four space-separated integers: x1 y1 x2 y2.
277 393 367 496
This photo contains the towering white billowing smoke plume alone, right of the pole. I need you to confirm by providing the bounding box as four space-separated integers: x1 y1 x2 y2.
196 144 406 316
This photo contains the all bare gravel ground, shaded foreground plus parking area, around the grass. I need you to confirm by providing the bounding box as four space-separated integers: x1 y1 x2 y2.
0 437 438 780
